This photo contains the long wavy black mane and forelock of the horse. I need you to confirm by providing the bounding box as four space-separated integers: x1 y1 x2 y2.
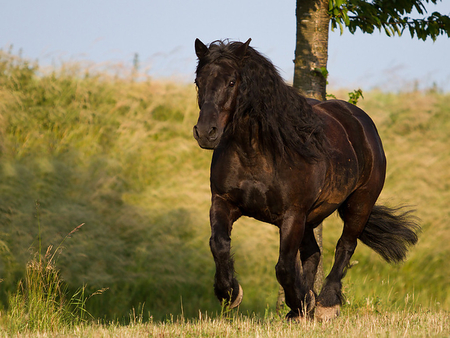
197 41 327 162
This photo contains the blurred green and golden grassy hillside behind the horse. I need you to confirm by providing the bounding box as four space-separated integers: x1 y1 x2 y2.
0 52 450 320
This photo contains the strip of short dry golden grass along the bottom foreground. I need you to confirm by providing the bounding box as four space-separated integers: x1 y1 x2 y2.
1 311 450 338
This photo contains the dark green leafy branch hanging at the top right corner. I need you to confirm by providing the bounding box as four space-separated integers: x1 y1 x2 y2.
329 0 450 41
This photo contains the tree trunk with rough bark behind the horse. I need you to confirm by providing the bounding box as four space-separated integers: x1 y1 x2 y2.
276 0 330 314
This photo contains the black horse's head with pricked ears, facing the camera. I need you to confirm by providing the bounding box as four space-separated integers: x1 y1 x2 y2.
193 39 251 149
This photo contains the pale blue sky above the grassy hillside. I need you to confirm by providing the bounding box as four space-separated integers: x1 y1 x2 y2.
0 0 450 91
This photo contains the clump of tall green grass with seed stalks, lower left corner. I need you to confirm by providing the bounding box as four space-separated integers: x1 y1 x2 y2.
2 220 99 334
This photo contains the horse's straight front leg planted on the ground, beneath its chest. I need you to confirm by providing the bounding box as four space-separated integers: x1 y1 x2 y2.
275 212 306 319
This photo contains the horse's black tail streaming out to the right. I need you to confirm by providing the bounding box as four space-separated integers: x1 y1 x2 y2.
359 205 420 263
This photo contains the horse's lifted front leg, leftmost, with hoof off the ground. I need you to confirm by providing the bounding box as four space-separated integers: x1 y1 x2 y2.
209 195 243 308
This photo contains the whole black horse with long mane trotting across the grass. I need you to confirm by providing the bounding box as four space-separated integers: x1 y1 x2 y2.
193 39 419 319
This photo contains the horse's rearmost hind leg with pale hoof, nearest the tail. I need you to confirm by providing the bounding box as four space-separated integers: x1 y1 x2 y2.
315 192 375 320
